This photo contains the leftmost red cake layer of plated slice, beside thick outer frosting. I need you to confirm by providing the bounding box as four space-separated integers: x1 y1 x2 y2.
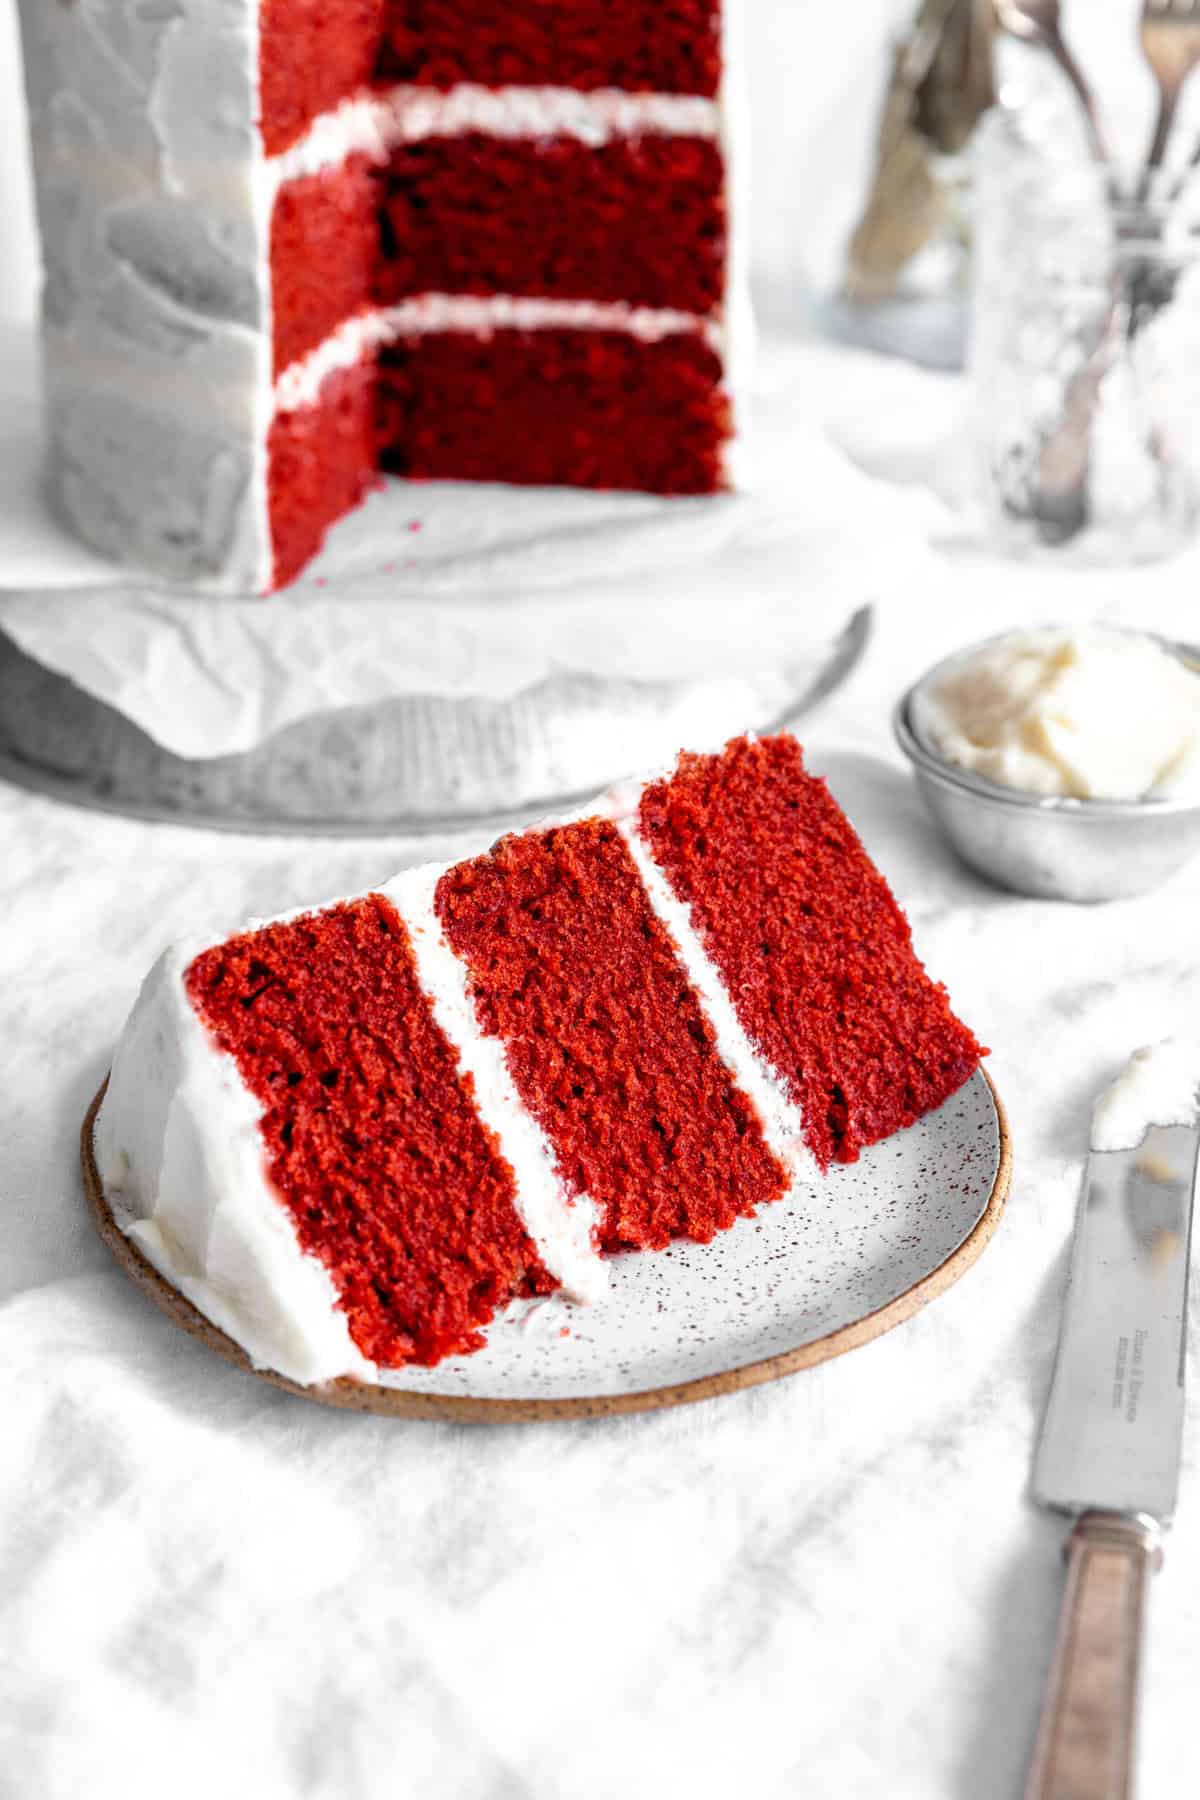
185 895 554 1366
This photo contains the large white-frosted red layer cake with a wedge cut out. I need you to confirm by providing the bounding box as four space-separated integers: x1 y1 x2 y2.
22 0 745 592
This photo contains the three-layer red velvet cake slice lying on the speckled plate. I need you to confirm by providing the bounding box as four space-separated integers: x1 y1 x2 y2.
95 736 981 1384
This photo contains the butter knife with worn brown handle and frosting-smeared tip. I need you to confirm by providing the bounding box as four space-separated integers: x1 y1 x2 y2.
1025 1046 1200 1800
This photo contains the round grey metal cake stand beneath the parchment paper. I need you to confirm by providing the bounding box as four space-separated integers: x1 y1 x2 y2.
0 607 873 837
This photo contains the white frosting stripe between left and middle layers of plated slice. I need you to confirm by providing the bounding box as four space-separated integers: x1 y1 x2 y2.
380 864 608 1301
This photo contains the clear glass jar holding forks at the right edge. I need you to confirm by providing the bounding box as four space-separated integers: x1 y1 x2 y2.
970 108 1200 563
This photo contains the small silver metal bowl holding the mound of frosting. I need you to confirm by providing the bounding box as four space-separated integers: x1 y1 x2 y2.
892 644 1200 902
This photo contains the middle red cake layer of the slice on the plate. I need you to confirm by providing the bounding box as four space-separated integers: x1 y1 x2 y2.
435 819 786 1249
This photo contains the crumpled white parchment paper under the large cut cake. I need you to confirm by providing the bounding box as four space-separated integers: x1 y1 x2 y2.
0 346 936 758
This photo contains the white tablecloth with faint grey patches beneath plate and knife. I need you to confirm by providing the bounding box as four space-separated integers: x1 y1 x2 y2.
0 313 1200 1800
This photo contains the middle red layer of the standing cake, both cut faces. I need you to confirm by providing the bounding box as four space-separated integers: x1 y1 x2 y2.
270 135 725 374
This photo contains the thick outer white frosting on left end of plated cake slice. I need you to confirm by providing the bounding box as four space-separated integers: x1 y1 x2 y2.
95 943 376 1386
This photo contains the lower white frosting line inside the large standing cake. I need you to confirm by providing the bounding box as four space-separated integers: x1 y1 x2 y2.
275 293 721 412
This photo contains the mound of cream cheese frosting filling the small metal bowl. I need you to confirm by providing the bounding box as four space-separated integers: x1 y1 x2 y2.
914 626 1200 799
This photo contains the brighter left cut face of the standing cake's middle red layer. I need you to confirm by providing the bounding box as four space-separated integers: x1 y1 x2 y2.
270 157 380 374
